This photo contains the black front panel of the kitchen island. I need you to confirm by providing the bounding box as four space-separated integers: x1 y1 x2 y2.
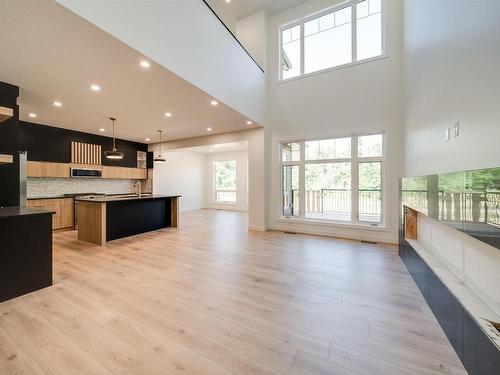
106 199 171 241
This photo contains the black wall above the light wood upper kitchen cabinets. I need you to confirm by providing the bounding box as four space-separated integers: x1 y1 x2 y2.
19 121 148 168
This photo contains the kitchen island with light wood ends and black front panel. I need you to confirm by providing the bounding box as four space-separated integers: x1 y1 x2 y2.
77 195 180 245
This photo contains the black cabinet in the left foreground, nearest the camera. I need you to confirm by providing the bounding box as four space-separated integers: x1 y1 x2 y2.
0 209 52 302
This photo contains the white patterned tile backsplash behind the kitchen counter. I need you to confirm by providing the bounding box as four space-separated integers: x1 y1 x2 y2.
27 178 135 198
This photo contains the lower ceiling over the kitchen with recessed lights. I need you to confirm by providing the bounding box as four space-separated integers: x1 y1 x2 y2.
0 0 259 143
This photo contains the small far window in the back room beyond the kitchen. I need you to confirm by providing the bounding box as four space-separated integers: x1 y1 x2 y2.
212 160 236 203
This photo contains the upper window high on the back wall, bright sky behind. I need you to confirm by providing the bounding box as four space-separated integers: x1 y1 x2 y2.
280 0 383 80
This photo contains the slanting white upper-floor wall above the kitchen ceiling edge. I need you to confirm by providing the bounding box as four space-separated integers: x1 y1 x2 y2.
57 0 266 124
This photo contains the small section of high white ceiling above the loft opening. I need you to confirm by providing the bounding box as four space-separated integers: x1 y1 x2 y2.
209 0 304 20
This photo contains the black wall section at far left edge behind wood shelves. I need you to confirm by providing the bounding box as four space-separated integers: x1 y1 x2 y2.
0 82 19 207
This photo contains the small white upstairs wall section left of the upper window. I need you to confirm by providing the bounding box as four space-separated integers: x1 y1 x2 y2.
236 10 267 70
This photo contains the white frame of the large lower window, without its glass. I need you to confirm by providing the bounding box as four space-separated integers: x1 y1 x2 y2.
278 131 387 229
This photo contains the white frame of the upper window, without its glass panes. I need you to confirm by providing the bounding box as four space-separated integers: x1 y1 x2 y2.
278 0 388 83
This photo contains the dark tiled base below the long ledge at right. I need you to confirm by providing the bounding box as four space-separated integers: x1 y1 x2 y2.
399 231 500 375
